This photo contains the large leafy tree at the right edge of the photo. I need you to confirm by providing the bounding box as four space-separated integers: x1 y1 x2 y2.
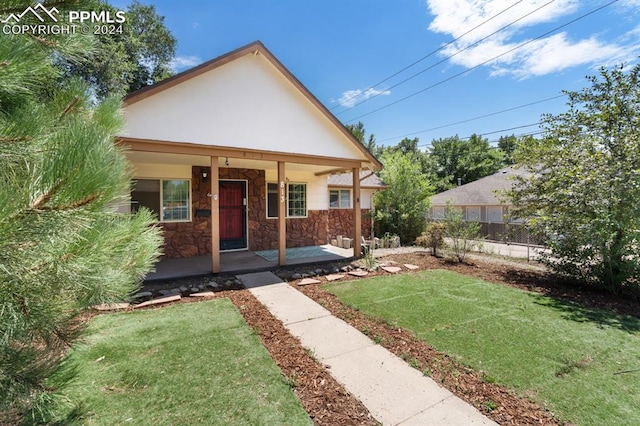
510 66 640 295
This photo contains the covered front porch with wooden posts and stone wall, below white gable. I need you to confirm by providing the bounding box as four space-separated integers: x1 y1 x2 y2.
122 139 362 275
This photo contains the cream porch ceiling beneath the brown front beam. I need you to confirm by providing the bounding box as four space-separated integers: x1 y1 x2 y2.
126 151 356 174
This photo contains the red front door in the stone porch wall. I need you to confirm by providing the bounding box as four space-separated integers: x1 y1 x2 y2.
219 181 247 250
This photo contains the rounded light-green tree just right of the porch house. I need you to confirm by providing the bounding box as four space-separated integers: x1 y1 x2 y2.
374 151 433 243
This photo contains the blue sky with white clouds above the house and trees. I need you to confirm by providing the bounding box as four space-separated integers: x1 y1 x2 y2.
111 0 640 148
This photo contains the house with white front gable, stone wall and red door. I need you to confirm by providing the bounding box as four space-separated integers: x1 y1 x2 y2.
119 42 382 272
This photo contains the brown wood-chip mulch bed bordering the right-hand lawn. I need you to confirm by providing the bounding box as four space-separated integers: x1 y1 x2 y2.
291 252 640 425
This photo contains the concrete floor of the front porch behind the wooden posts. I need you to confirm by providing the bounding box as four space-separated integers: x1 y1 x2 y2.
144 244 353 282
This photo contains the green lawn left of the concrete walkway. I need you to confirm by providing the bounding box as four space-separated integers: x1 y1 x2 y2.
53 299 311 425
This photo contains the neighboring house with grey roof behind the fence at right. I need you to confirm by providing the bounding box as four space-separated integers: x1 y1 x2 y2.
429 166 530 243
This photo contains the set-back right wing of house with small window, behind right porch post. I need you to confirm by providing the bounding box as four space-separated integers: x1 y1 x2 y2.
328 170 387 239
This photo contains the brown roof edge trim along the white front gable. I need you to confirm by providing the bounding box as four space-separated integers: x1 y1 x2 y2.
124 41 382 169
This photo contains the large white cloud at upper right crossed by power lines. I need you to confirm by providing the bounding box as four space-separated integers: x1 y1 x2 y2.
427 0 640 78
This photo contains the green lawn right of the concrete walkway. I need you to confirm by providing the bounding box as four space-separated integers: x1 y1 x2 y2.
326 270 640 425
